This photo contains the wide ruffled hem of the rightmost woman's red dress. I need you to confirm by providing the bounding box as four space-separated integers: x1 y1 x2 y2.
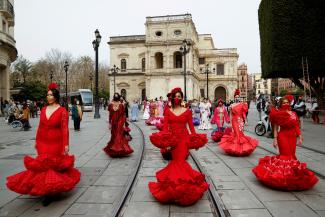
252 156 318 191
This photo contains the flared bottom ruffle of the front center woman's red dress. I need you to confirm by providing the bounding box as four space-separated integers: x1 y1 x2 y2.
149 161 209 206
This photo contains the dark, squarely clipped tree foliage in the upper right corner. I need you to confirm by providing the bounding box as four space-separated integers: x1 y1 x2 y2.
258 0 325 109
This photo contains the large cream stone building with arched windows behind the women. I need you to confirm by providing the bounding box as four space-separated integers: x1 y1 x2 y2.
108 14 238 100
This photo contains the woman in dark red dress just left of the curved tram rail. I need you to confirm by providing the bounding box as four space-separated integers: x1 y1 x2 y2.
103 93 133 157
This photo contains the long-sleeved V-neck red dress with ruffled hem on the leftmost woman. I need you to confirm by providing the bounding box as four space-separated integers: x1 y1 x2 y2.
7 107 80 196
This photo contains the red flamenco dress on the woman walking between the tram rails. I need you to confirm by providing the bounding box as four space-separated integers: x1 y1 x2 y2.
149 109 209 206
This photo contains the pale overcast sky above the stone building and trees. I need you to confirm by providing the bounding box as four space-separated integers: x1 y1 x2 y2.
15 0 261 73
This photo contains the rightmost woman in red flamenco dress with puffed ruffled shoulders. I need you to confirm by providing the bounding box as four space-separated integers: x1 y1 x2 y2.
253 96 318 191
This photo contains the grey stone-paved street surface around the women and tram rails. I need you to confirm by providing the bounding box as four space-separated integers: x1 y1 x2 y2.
0 108 325 217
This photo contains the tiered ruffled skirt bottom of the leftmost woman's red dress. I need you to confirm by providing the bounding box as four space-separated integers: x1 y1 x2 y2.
7 155 80 196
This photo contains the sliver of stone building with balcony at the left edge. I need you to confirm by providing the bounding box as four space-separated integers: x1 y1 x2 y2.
0 0 17 100
